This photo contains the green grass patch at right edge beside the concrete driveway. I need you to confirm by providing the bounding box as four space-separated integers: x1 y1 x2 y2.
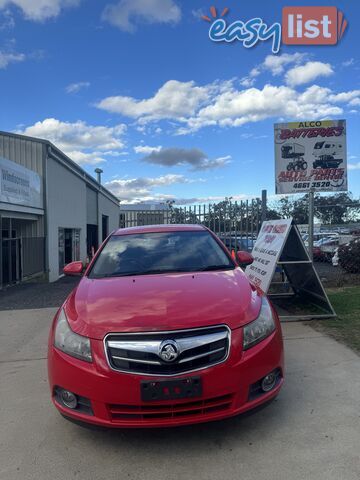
309 286 360 354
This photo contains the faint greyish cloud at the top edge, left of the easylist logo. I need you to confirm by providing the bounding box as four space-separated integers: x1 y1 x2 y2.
102 0 181 32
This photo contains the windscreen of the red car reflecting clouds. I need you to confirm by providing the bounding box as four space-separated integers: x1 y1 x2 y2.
89 231 235 278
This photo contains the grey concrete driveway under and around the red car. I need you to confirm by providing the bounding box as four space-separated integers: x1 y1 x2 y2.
0 308 360 480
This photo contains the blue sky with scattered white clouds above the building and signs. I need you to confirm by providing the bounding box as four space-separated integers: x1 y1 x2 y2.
0 0 360 203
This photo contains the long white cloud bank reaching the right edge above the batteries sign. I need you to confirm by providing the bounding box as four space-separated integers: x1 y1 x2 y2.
97 73 360 135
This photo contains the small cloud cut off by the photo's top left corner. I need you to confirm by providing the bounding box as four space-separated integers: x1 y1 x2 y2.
0 0 81 22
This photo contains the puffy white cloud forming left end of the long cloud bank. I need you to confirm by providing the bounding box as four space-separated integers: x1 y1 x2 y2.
97 80 209 123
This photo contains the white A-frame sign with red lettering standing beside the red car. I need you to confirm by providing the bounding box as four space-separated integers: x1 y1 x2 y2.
245 219 335 321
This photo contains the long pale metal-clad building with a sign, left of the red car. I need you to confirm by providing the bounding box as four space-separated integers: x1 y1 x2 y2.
0 132 119 288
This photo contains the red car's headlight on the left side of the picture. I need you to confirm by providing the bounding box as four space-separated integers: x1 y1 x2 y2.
54 310 92 362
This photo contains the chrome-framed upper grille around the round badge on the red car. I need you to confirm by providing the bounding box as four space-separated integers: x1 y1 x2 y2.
104 325 230 375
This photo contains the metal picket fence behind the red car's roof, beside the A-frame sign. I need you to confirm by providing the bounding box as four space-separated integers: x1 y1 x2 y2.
120 198 266 251
